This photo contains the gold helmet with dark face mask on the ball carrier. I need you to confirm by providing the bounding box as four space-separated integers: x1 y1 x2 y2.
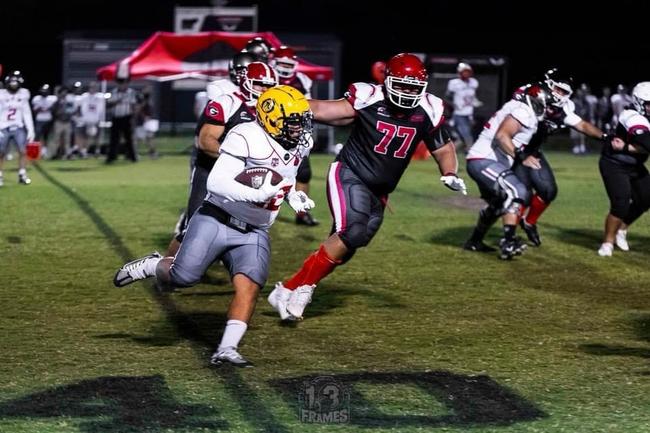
256 86 313 150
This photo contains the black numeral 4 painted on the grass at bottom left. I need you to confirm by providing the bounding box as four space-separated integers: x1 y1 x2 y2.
0 376 228 433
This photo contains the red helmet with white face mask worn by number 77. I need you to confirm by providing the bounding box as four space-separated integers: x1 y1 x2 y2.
384 53 429 108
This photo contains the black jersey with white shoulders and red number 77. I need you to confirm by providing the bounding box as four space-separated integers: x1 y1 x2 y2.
337 83 449 195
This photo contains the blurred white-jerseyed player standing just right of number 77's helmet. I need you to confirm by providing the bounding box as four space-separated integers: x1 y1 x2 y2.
446 62 479 152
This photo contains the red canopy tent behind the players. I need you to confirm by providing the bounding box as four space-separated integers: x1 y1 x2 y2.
97 32 333 81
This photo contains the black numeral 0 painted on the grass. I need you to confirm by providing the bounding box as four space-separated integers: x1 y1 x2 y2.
270 371 547 429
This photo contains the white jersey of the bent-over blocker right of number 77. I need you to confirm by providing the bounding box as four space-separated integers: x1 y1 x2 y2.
467 100 538 164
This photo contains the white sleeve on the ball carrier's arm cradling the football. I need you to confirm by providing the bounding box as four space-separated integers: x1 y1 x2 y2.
207 153 268 203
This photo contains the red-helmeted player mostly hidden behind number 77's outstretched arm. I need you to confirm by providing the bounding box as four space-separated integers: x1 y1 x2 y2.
271 45 319 226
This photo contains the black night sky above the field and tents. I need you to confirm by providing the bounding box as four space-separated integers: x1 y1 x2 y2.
0 0 650 94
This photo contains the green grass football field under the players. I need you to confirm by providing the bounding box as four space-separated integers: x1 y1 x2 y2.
0 139 650 433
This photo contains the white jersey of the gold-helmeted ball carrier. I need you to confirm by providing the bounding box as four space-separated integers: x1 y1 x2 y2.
207 122 313 230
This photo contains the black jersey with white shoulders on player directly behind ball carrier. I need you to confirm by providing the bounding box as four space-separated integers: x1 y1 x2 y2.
194 93 256 170
